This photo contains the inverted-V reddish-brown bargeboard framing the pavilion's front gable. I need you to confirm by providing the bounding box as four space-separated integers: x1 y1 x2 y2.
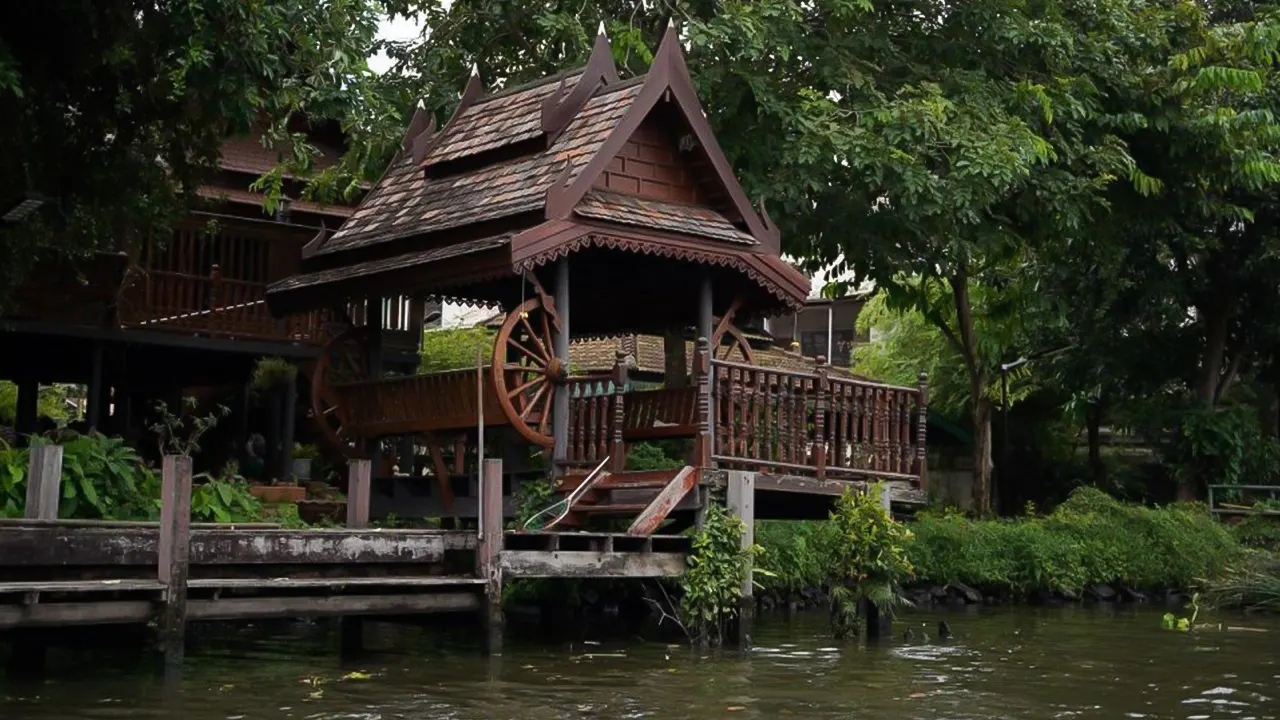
547 23 781 255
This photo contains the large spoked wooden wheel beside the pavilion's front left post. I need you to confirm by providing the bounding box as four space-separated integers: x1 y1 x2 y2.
490 297 568 447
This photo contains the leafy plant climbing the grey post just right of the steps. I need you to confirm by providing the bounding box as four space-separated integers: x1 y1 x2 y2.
680 502 756 644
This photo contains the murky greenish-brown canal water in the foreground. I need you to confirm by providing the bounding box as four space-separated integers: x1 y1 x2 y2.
0 607 1280 720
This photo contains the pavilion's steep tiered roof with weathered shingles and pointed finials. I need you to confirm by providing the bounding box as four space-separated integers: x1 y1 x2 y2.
268 27 809 311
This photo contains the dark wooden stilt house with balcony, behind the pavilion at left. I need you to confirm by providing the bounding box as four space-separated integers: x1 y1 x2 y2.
0 119 422 474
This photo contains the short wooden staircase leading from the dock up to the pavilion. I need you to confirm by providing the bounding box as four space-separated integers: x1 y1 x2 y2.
544 465 699 537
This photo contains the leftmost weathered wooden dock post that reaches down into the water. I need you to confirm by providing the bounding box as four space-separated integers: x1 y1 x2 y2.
159 455 191 676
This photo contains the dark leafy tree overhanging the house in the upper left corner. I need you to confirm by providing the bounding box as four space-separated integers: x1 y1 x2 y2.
0 0 401 305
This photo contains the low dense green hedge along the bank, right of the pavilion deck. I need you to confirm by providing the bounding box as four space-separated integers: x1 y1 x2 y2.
908 488 1239 596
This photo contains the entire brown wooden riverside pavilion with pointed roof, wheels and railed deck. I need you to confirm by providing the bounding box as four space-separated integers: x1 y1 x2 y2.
266 28 925 534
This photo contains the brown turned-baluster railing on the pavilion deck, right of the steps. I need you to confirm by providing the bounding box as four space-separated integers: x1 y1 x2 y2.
710 357 928 479
